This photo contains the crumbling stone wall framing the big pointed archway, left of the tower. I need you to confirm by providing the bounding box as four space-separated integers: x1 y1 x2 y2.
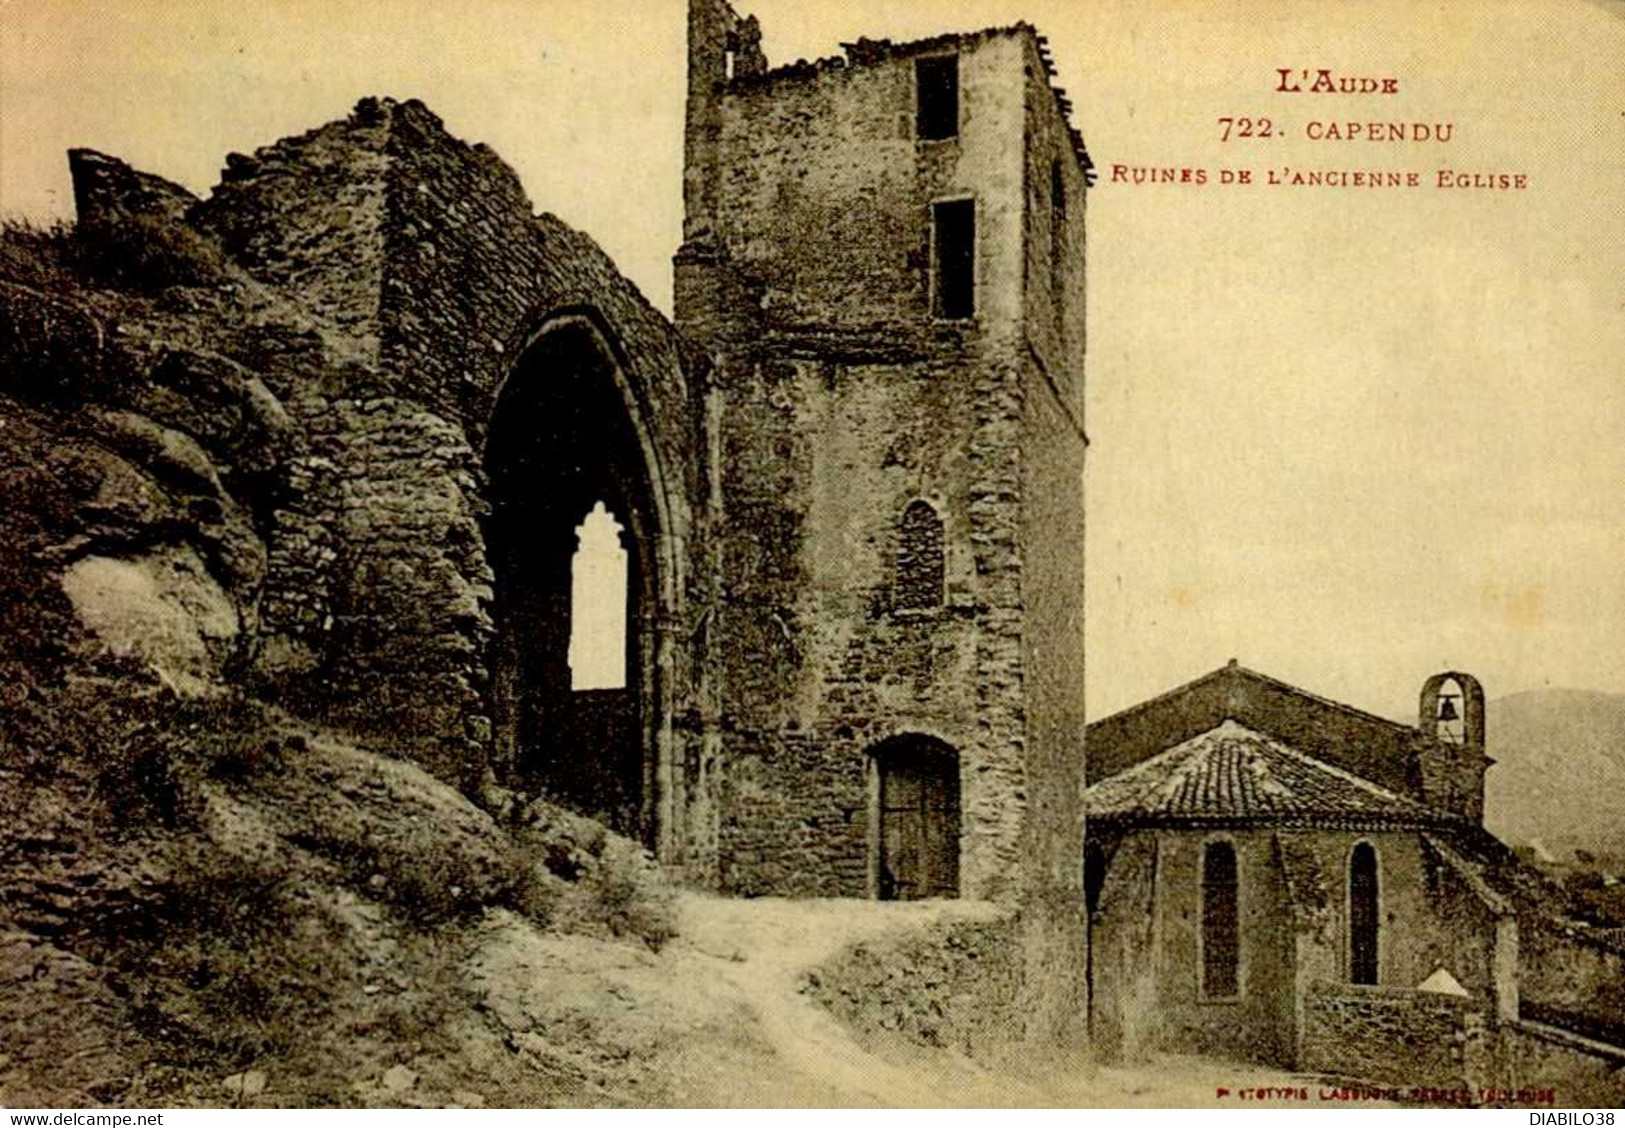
52 99 715 881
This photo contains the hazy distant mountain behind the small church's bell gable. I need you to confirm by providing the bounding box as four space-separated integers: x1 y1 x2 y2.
1484 689 1625 861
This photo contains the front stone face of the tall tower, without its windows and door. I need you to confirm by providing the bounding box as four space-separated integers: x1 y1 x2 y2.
678 28 1027 897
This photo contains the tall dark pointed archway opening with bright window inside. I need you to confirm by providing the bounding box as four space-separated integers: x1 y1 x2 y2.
484 314 663 848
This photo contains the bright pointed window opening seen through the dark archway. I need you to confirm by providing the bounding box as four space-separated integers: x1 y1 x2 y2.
570 502 627 691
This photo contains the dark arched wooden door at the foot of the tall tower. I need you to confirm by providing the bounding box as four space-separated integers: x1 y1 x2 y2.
879 744 959 900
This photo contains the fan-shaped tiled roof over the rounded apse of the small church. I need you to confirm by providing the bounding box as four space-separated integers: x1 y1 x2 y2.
1084 720 1451 826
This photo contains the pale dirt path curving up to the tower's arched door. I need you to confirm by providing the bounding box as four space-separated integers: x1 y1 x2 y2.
448 894 1384 1108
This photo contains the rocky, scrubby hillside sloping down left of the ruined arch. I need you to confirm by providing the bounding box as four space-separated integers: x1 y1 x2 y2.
0 203 673 1107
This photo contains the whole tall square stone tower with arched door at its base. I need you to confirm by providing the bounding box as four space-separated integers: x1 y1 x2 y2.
676 0 1090 1027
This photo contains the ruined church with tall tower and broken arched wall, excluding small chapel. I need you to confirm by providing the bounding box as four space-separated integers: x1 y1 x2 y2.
50 0 1090 951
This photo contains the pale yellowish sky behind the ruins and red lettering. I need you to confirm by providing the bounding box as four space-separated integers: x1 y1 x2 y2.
0 0 1625 717
